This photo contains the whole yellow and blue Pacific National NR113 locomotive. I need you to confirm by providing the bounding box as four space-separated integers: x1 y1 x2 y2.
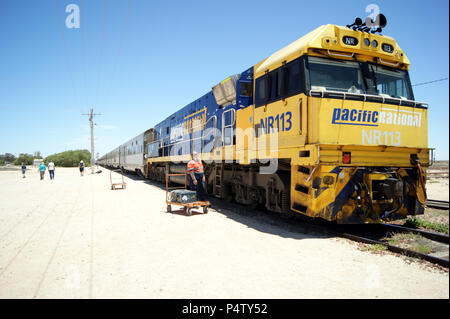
101 15 431 223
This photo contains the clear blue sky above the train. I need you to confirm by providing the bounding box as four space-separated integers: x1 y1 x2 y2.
0 0 449 159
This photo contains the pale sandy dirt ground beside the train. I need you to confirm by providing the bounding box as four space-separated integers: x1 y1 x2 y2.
0 168 449 298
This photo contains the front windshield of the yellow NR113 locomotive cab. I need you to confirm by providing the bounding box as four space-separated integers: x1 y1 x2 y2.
308 57 414 100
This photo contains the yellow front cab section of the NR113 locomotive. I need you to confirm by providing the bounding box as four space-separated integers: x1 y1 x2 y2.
229 19 430 223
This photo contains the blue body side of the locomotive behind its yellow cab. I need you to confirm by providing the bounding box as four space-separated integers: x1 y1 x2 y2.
147 67 253 158
